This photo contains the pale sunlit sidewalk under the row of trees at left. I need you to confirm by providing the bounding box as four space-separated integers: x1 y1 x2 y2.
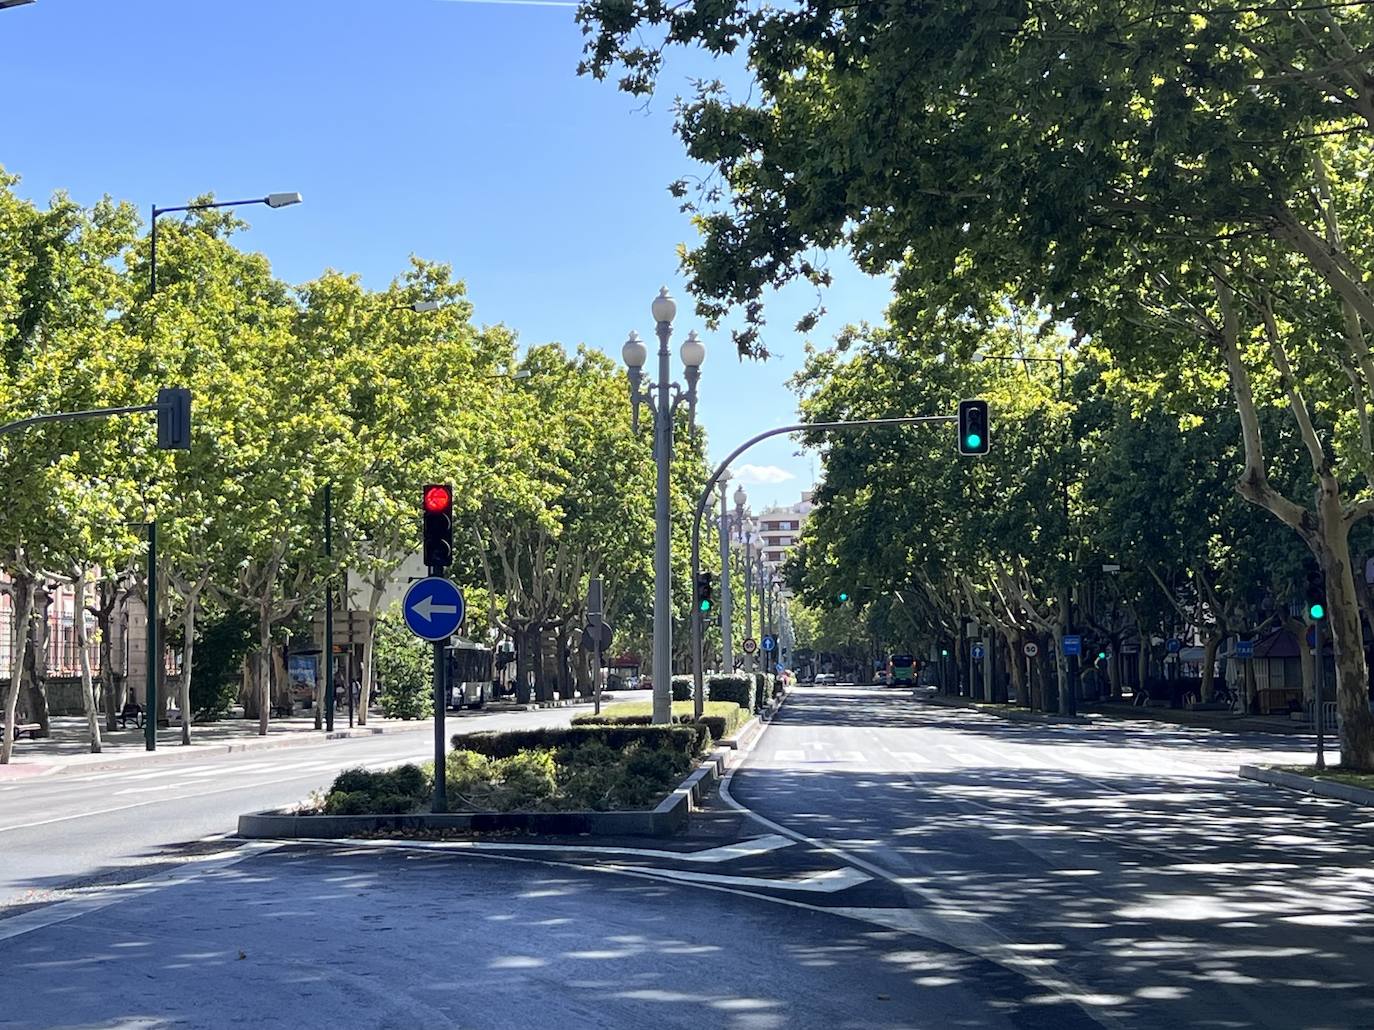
0 711 434 781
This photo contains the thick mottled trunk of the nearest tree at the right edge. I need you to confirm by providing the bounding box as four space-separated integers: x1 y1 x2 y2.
1316 505 1374 770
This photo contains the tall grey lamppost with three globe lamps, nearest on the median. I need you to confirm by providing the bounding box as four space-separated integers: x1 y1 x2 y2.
621 286 706 724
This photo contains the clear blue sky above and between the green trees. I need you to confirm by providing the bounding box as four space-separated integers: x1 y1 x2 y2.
0 0 889 510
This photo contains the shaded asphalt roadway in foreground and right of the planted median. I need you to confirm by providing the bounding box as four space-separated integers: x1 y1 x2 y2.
0 687 1374 1030
